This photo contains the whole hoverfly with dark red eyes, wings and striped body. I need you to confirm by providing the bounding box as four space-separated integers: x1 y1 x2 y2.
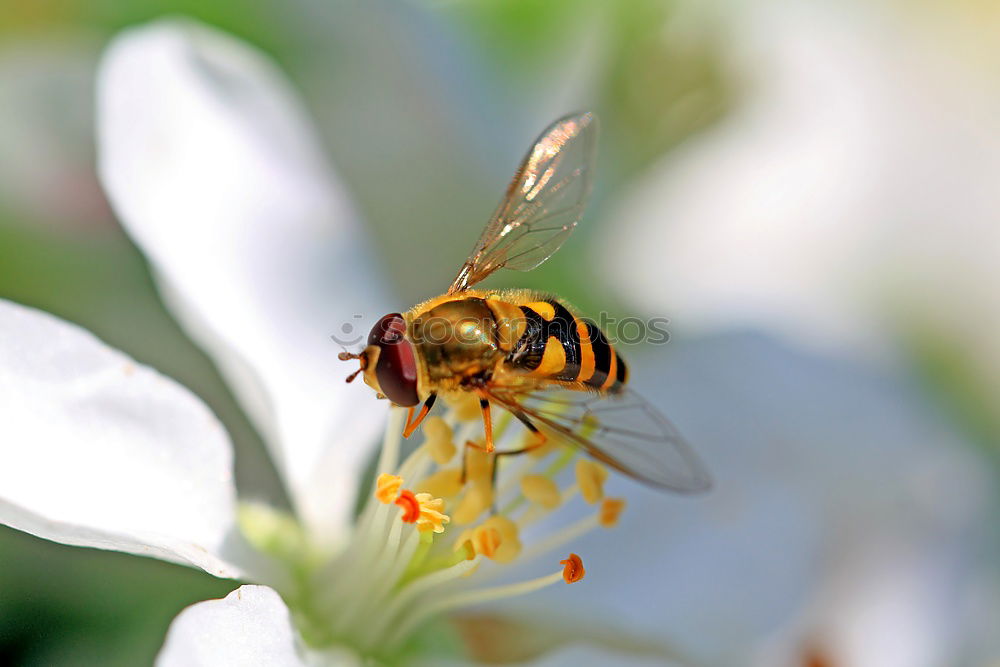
340 113 710 493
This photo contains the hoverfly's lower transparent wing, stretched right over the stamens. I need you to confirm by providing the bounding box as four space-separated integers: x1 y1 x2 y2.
490 387 712 493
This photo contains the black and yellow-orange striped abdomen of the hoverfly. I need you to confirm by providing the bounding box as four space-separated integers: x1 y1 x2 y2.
507 299 628 393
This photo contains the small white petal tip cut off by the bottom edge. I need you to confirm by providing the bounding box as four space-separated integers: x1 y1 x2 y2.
156 586 307 667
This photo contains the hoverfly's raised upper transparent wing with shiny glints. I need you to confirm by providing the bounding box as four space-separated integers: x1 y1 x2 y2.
448 112 597 294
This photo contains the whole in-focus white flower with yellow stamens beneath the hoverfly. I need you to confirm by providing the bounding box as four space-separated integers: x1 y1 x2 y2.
0 22 648 665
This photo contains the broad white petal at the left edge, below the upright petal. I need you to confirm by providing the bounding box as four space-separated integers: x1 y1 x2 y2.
0 301 241 577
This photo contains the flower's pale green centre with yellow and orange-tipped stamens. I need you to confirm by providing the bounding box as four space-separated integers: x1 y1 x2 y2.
282 402 624 657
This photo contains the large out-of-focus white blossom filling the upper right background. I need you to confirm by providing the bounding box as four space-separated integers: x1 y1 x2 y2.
599 3 1000 360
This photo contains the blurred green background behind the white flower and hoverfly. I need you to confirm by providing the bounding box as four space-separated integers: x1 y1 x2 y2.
0 0 1000 665
